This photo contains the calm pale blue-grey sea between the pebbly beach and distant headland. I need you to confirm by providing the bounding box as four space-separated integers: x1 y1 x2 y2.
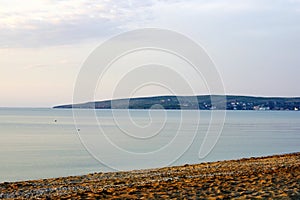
0 108 300 182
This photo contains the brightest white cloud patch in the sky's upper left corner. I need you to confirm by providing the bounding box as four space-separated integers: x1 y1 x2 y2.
0 0 122 28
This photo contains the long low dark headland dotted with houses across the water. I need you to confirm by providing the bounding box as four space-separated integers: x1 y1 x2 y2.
53 95 300 111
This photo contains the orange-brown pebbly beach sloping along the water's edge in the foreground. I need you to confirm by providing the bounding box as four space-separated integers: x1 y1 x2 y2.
0 153 300 199
